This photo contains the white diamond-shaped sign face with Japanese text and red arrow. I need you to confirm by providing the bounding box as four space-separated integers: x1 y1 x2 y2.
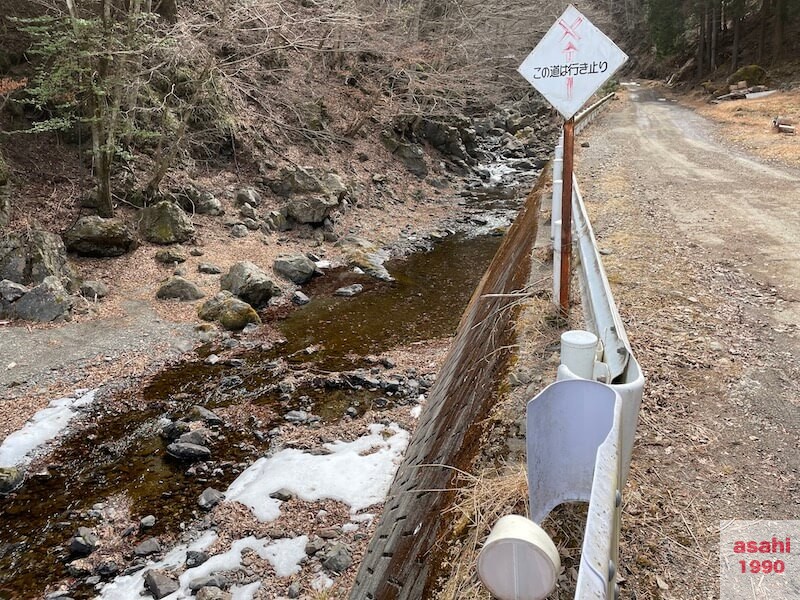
518 4 628 119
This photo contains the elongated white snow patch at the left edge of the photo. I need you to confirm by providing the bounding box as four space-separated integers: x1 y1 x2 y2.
0 390 97 467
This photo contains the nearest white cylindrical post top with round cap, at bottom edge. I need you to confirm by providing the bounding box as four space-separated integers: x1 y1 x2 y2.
478 515 561 600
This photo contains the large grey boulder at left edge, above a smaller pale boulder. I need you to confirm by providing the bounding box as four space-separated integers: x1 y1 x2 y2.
0 230 77 290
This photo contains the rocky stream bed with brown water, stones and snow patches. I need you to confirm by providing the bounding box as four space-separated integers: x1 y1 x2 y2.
0 101 560 599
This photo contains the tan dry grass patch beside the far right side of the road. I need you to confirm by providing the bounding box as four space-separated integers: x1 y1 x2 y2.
690 90 800 167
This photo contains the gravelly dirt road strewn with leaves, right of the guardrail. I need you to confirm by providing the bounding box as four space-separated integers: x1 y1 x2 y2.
577 86 800 600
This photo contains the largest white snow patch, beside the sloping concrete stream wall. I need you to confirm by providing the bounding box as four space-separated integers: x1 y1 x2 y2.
225 424 409 521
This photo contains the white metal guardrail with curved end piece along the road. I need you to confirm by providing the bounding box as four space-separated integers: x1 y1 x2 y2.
482 94 645 600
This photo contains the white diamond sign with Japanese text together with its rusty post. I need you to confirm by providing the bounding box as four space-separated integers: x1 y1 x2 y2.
518 4 628 315
